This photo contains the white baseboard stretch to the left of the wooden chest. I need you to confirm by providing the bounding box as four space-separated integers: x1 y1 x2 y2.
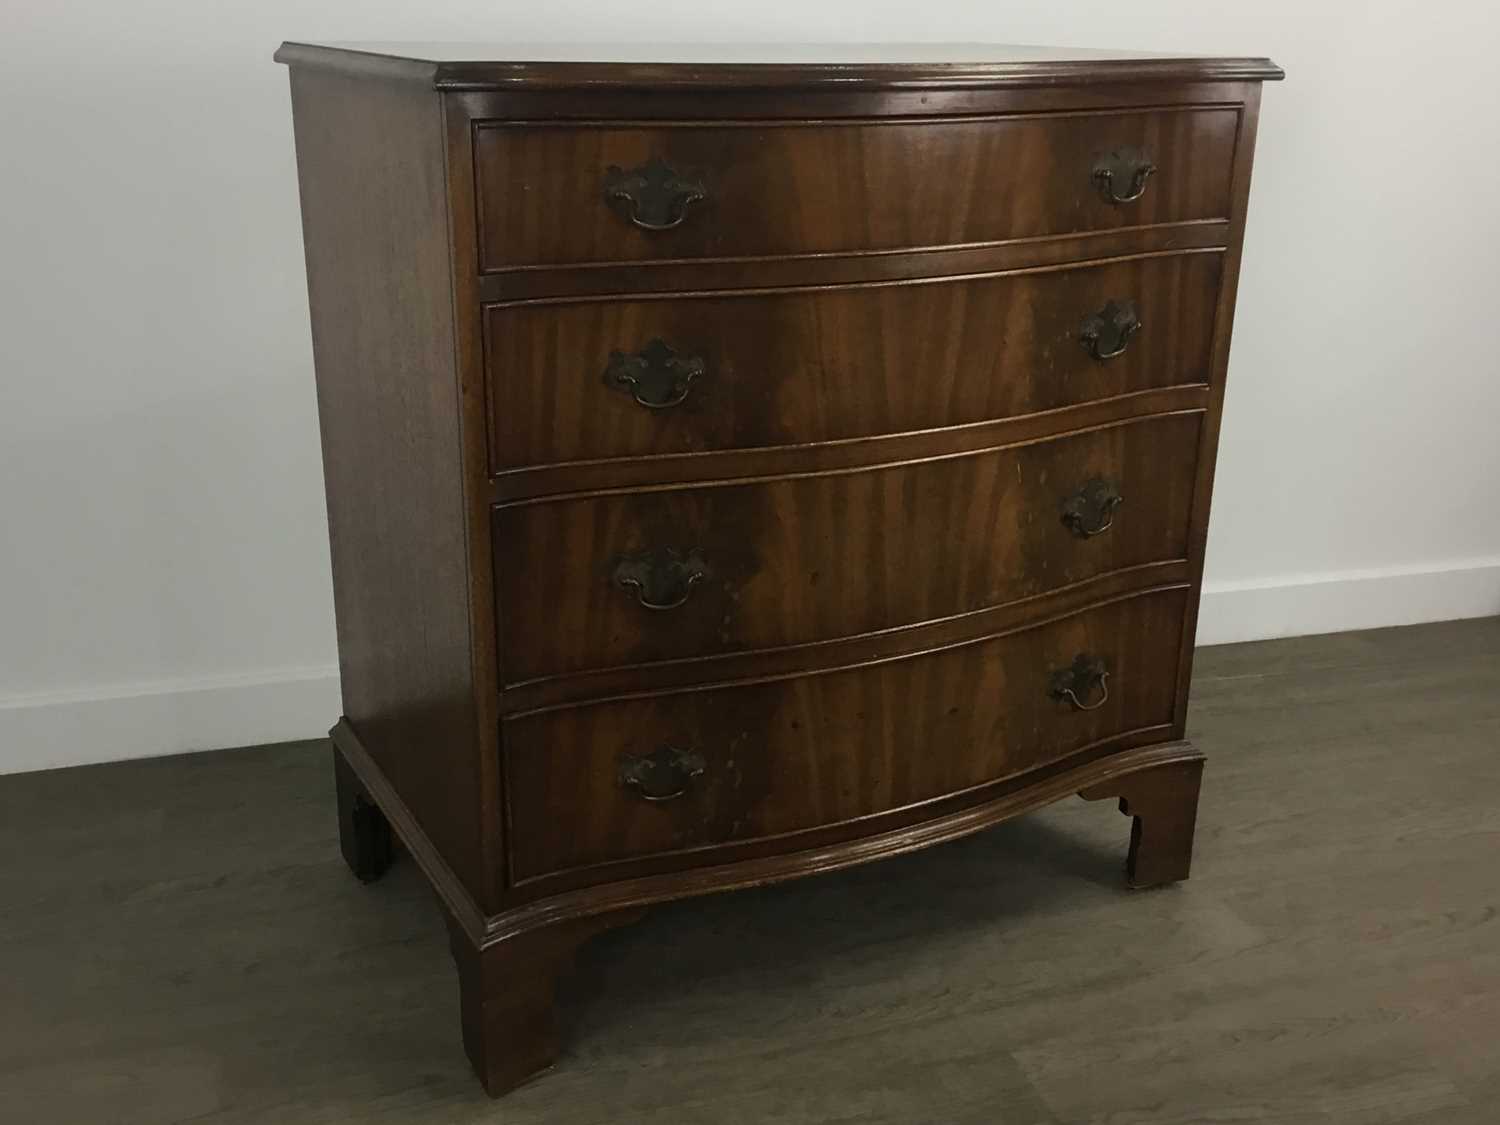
0 668 341 774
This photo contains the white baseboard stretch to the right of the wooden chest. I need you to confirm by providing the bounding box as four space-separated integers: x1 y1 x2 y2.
1197 558 1500 645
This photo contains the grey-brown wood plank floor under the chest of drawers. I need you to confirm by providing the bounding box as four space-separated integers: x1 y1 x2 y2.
0 618 1500 1125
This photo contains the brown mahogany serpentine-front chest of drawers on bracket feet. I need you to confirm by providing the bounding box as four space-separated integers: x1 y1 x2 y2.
278 44 1280 1092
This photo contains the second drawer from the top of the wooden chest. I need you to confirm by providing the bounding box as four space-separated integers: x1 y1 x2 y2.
485 252 1221 470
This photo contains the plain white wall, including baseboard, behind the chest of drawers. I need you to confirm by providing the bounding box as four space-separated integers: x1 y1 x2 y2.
0 0 1500 771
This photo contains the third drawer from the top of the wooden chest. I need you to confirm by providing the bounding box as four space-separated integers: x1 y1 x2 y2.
494 413 1202 683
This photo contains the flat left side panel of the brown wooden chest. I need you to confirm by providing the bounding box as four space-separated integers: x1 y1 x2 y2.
291 71 498 905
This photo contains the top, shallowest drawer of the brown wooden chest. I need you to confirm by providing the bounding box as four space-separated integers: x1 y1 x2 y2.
474 108 1239 272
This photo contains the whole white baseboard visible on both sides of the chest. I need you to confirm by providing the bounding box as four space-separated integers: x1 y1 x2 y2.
0 560 1500 774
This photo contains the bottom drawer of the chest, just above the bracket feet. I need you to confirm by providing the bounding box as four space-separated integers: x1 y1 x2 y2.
503 588 1187 881
